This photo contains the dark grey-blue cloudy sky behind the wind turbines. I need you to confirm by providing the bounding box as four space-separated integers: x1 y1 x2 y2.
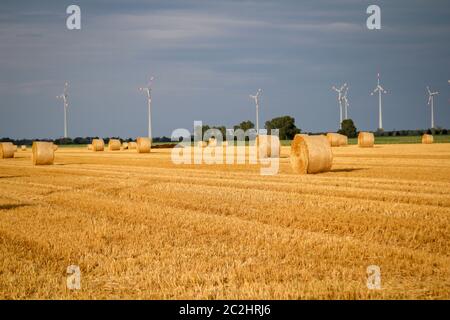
0 0 450 138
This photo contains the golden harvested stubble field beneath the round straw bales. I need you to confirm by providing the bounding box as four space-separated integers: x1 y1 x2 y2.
0 144 450 299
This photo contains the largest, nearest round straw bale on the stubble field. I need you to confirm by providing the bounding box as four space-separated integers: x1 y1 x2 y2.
290 135 333 174
